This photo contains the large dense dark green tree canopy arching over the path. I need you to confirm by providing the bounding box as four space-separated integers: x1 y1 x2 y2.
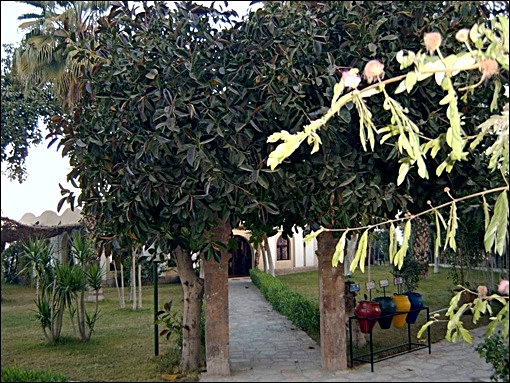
56 1 504 260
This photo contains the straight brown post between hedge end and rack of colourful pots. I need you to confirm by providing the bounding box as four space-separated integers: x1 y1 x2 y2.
316 231 347 371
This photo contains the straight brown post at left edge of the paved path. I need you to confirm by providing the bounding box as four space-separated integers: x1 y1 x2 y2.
203 218 232 376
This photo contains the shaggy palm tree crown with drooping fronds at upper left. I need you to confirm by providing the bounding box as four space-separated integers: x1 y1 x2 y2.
14 1 111 111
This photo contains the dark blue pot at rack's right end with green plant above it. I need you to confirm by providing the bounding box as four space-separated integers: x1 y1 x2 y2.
391 255 424 324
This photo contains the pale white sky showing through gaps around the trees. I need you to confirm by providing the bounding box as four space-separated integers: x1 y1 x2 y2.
0 1 260 220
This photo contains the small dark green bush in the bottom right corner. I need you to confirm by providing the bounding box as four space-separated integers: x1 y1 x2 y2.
476 332 509 382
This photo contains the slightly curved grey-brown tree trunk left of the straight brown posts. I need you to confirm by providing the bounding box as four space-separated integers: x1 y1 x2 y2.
175 248 204 373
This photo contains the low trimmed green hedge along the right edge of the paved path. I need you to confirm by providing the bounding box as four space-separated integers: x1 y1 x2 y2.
250 269 320 334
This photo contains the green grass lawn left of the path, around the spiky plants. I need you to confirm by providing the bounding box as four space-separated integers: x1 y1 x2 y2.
1 284 187 382
